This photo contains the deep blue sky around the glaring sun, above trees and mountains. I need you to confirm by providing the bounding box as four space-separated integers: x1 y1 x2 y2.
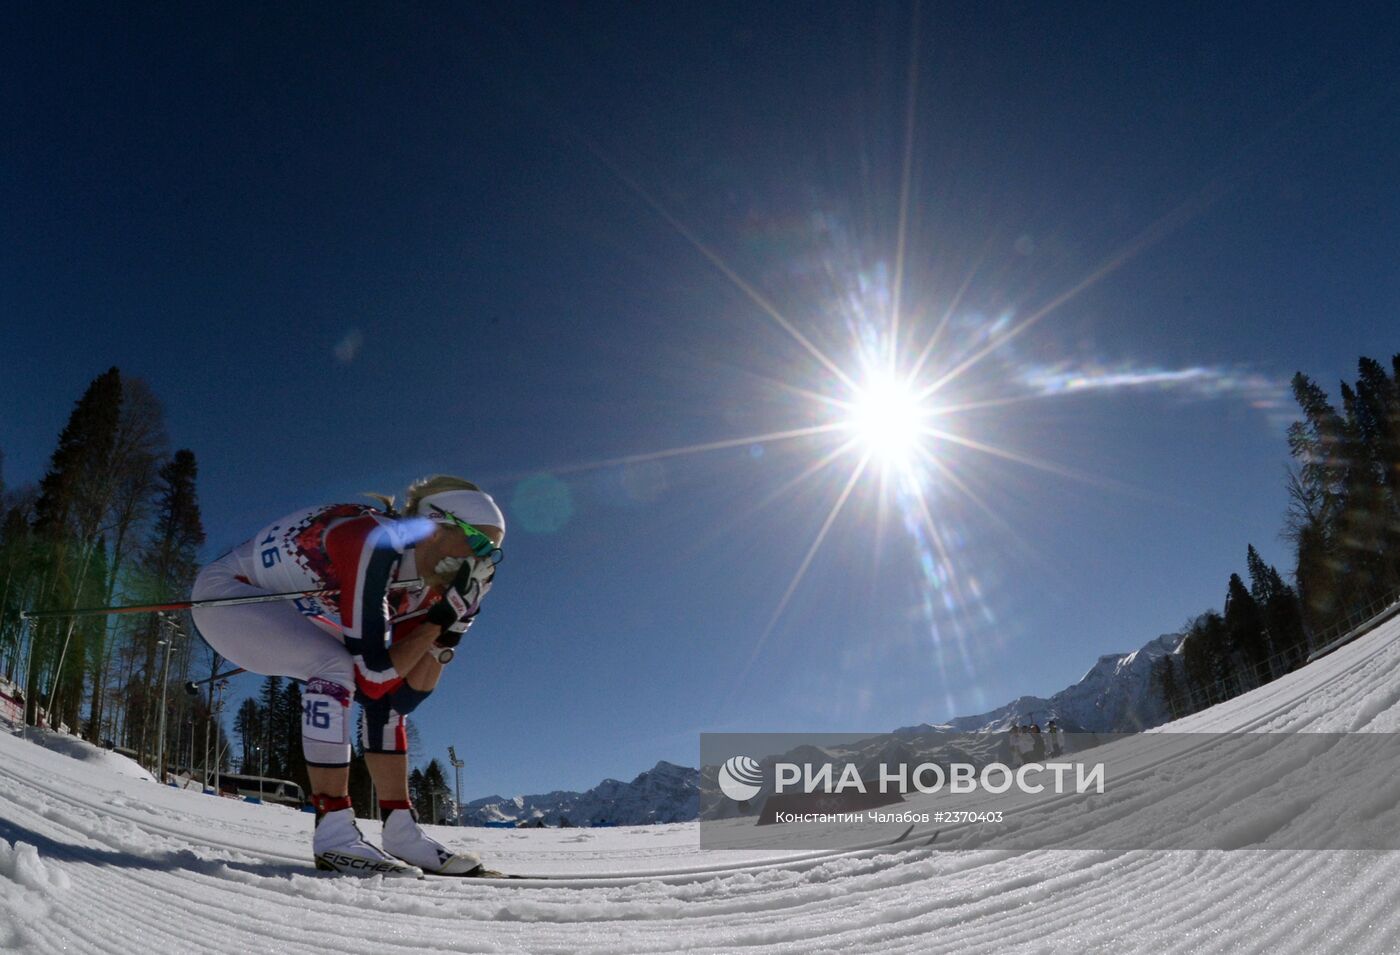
0 3 1400 795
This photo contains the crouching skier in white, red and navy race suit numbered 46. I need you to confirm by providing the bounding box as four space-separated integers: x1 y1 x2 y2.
193 475 505 877
